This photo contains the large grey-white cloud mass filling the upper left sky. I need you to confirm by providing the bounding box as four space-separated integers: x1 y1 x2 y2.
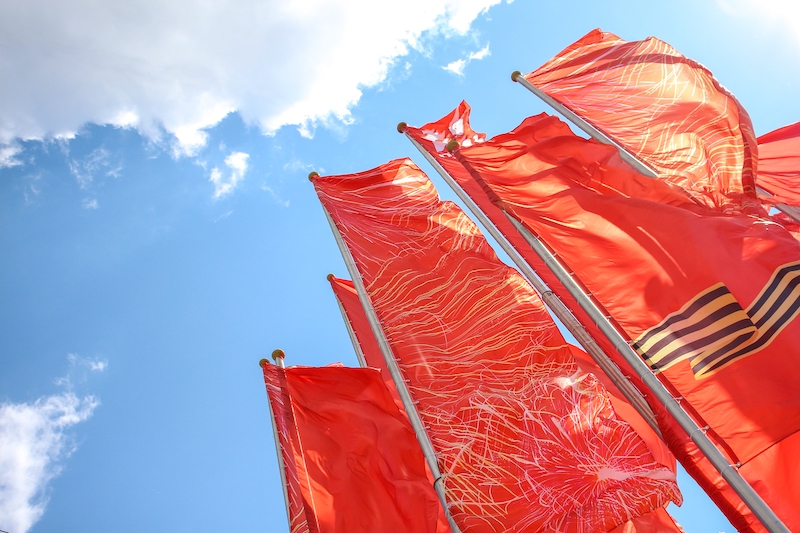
0 0 501 153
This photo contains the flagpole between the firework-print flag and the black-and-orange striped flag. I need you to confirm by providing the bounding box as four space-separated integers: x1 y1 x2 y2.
404 132 661 437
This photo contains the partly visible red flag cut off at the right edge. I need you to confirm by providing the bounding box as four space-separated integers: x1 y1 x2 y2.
758 122 800 207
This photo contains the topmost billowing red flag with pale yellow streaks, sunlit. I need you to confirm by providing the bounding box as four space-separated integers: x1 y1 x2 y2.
525 30 760 213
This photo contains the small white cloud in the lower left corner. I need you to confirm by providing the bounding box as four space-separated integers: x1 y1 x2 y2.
0 392 98 533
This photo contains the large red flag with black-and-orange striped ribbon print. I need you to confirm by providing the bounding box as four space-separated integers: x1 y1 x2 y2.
456 110 800 530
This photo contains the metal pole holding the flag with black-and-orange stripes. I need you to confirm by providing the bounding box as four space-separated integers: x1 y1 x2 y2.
452 143 790 533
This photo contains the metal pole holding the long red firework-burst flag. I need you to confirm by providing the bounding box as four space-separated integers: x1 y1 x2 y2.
308 176 461 533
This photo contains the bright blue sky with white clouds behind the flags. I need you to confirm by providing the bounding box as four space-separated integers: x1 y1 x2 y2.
0 0 800 533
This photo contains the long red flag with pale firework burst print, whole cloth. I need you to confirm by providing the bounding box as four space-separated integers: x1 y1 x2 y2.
313 160 680 533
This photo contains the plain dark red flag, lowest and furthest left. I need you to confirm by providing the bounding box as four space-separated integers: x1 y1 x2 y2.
263 364 442 533
